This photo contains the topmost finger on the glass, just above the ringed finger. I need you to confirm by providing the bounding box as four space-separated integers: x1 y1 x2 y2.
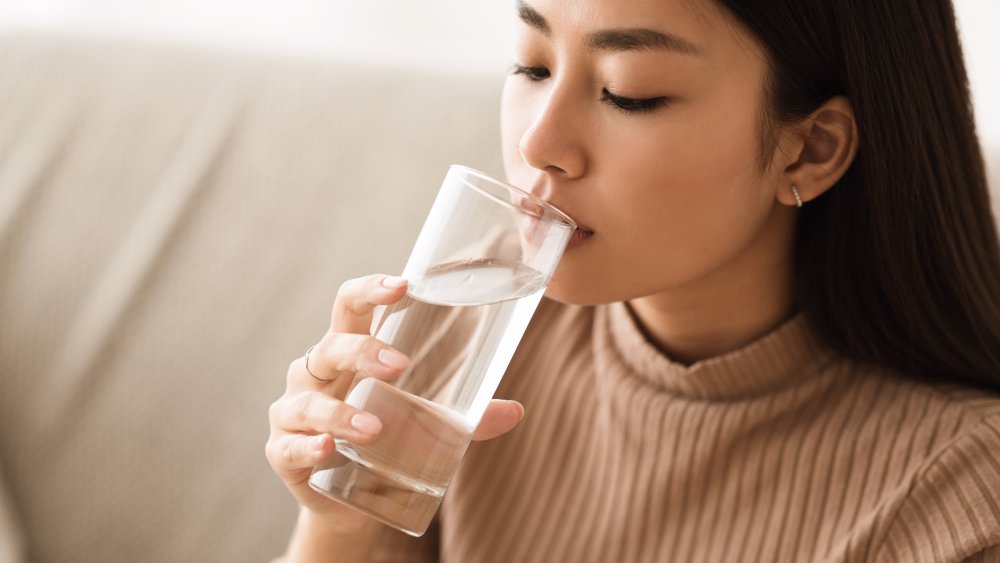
330 274 406 334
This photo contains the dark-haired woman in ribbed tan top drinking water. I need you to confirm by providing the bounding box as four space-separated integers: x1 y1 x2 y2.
267 0 1000 562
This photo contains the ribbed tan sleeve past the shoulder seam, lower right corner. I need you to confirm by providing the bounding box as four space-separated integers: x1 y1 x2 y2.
874 414 1000 563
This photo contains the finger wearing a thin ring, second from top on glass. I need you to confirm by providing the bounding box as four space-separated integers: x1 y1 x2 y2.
303 332 410 381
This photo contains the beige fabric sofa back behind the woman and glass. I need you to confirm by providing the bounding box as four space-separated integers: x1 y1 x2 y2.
0 33 502 562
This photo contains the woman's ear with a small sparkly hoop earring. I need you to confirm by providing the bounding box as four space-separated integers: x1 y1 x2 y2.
776 96 858 207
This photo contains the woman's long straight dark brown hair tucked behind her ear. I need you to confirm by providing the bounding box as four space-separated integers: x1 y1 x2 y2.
719 0 1000 390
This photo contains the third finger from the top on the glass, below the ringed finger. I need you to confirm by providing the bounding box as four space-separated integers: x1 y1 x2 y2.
270 391 382 445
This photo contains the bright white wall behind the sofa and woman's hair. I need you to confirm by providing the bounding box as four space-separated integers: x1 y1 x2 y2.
0 0 1000 165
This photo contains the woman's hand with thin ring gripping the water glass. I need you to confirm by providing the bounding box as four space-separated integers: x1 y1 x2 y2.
265 275 524 532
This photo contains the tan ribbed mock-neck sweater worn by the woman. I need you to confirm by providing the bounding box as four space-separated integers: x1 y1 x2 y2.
375 300 1000 563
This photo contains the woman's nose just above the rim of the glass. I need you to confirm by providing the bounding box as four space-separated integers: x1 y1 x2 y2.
517 84 587 179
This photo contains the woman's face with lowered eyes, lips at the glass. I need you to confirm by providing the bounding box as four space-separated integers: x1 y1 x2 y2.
502 0 793 304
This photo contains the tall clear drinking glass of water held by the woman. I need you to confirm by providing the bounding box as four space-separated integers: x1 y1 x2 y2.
309 166 576 536
